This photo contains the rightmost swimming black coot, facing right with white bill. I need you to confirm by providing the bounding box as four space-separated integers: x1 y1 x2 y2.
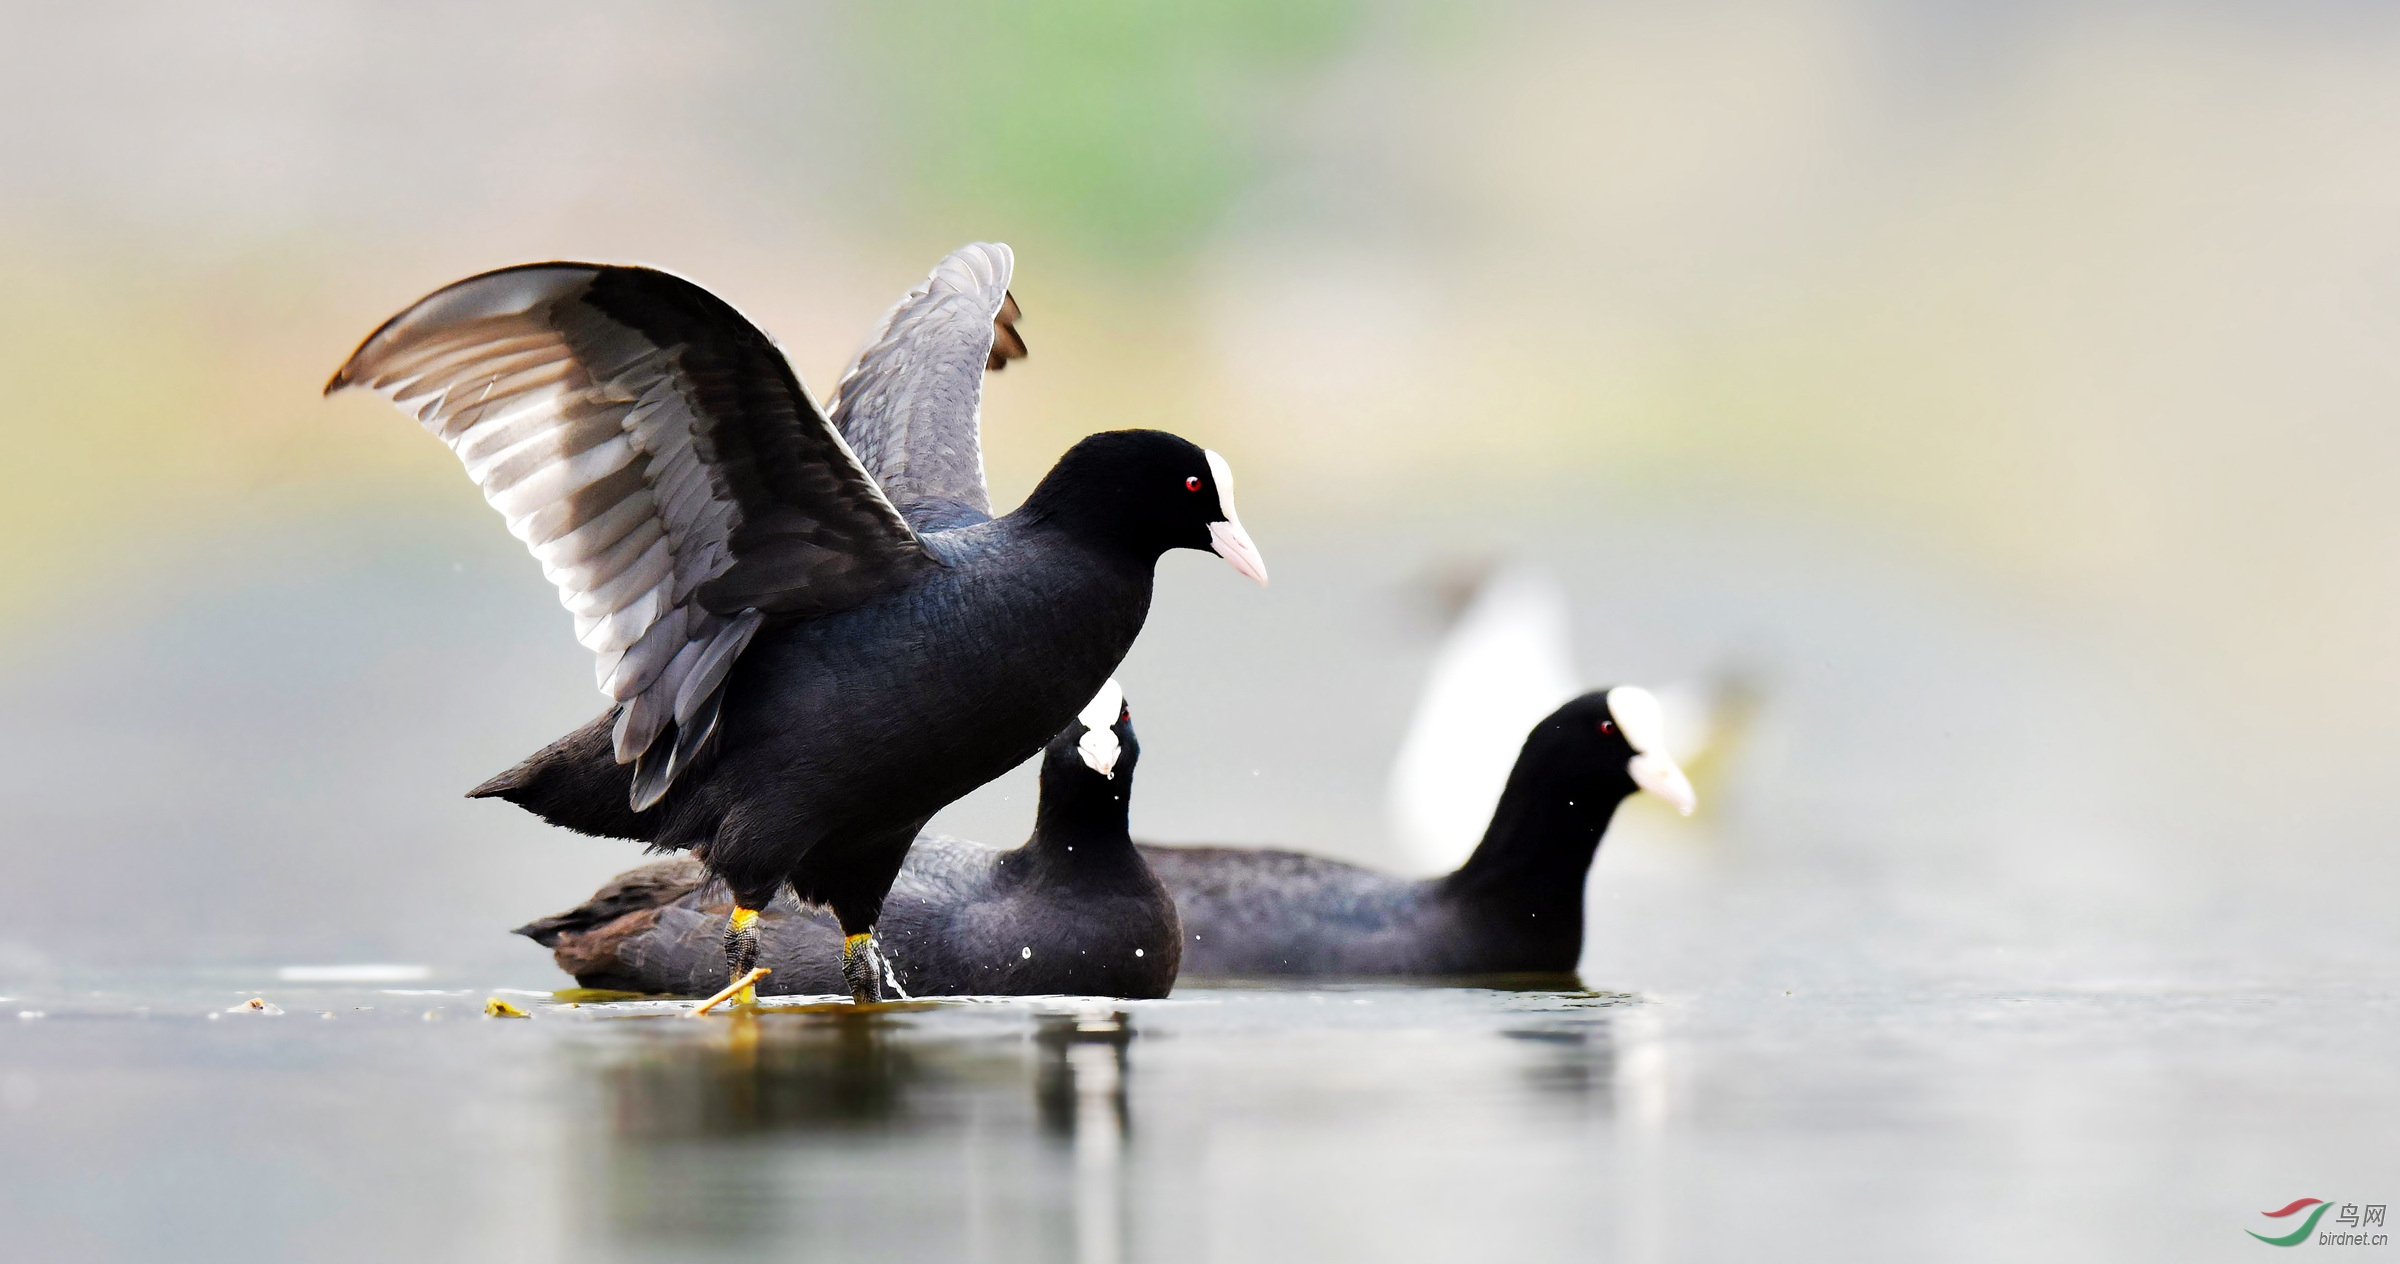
1140 686 1692 976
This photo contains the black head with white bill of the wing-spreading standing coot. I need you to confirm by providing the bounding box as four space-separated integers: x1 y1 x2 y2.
1025 429 1267 583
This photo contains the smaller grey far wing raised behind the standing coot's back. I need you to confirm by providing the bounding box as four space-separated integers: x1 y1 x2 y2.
833 242 1025 530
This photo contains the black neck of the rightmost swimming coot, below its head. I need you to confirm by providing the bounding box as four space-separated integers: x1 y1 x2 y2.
1442 758 1632 943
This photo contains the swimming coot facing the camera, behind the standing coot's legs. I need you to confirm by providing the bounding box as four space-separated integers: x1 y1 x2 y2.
516 681 1181 998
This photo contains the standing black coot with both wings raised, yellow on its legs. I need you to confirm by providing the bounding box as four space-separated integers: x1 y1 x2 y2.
326 242 1265 1000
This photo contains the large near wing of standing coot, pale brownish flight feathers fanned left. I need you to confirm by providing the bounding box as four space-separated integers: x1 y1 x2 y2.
326 264 929 811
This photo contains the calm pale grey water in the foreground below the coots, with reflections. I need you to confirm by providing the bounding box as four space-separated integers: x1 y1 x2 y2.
0 964 2400 1262
